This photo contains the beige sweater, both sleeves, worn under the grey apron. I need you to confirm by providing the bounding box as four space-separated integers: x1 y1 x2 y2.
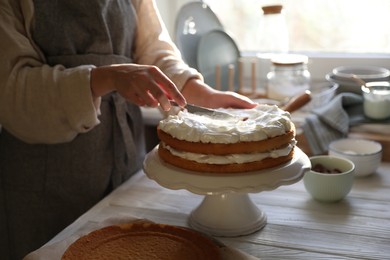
0 0 201 144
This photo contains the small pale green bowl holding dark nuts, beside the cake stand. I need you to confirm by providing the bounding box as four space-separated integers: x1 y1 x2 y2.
303 155 355 202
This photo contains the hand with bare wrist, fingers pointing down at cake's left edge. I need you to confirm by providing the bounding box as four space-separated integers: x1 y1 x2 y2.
91 64 186 110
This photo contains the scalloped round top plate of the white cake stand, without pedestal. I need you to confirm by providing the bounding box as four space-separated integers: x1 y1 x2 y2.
144 146 311 195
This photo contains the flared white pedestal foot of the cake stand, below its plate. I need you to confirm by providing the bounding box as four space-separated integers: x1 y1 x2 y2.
189 193 267 237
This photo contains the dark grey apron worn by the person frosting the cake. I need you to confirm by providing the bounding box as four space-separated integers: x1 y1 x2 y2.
0 0 145 259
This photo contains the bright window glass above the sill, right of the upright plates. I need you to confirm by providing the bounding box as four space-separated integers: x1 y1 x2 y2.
204 0 390 54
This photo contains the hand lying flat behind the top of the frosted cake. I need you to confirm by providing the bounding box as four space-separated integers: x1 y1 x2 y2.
182 79 257 108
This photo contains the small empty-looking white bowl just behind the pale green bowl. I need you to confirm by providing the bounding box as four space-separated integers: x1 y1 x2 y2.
328 138 382 177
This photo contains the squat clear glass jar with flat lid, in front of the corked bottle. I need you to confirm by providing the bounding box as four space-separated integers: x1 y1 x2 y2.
267 54 310 101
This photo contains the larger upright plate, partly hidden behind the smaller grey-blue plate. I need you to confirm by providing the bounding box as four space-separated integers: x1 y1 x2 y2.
175 1 223 69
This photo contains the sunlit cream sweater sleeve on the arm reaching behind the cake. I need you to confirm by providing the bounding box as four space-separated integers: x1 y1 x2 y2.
133 0 203 90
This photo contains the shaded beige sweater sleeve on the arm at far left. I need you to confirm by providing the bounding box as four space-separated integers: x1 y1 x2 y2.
0 0 99 144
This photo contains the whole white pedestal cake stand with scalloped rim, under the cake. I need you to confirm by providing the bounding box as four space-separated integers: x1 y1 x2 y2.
144 146 311 237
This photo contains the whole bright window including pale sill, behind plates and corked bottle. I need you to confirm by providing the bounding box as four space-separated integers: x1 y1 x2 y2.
156 0 390 81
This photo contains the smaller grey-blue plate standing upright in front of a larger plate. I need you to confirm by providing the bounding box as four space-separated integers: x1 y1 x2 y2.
197 30 240 90
